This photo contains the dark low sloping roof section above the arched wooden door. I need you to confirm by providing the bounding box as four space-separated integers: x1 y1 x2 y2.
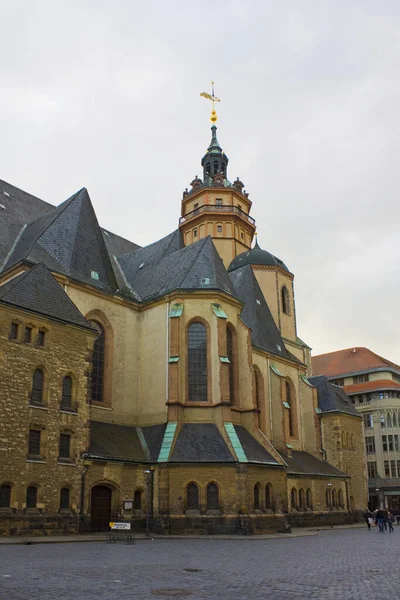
88 421 148 462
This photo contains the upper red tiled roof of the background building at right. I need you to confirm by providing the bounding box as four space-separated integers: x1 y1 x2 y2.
311 347 400 377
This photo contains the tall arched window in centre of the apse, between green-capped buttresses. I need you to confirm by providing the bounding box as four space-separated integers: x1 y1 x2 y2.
188 322 208 402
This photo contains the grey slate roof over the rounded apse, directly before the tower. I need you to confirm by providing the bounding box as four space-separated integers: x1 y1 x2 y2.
118 232 234 301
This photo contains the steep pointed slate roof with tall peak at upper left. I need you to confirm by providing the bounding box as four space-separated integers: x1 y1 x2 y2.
5 188 118 290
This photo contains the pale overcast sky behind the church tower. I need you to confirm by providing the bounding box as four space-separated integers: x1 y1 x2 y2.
0 0 400 363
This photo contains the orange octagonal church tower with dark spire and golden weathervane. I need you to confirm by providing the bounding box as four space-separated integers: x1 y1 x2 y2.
179 92 256 268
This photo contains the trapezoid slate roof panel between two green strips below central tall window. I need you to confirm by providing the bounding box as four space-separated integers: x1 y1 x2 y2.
170 423 235 463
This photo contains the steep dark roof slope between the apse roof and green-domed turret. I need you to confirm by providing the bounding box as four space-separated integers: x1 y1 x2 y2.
229 265 293 360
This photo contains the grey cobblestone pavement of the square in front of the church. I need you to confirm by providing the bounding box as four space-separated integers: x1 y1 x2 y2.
0 527 400 600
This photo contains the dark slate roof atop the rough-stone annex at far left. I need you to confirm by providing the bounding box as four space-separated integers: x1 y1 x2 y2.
0 263 91 329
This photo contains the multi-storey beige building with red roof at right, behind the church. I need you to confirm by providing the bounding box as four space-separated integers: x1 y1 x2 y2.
312 347 400 508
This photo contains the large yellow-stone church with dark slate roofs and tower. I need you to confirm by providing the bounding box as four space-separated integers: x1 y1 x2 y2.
0 117 367 535
